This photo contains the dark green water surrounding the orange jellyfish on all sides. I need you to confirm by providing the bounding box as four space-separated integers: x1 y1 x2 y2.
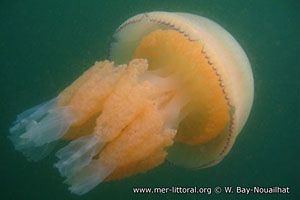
0 0 300 200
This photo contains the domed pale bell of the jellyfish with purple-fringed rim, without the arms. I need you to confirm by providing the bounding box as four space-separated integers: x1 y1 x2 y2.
110 12 254 168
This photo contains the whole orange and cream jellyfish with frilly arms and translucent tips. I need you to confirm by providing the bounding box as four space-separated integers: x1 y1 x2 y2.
9 12 254 195
